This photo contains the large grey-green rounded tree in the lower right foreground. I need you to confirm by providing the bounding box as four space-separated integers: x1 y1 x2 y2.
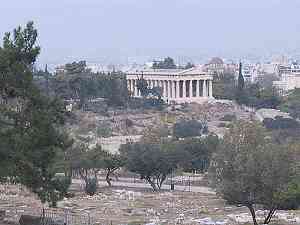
210 121 297 225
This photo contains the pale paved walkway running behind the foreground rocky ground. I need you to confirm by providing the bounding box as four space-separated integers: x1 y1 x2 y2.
72 179 216 194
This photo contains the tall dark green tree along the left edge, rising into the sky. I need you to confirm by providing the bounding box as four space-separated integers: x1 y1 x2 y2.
0 22 71 206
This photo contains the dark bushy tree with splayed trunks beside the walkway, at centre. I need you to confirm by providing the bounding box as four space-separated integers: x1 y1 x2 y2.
120 126 179 191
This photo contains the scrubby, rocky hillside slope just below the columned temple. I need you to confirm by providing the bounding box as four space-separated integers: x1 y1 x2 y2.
67 100 254 151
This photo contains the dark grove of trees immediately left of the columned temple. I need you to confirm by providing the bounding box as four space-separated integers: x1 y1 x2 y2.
51 69 129 108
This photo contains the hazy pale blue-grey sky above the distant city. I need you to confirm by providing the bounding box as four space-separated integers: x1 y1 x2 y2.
0 0 300 62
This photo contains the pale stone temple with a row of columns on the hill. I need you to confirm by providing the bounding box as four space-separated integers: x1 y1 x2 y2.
127 68 213 103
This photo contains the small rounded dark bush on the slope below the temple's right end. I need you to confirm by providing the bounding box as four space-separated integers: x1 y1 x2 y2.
173 120 203 138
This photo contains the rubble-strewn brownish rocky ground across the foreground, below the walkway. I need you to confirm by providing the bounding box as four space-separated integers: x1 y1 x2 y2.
0 186 300 225
